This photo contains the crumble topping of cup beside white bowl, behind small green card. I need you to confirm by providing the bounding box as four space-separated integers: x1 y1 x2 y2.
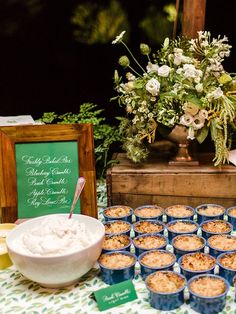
98 253 135 268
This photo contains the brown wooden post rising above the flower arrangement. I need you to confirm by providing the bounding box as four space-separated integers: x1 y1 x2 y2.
182 0 206 38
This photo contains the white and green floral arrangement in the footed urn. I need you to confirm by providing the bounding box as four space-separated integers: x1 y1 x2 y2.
112 31 236 166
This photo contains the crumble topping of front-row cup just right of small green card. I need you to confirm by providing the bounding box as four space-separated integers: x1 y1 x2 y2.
147 271 185 293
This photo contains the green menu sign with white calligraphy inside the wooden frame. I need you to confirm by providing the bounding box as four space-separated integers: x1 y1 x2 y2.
15 141 80 218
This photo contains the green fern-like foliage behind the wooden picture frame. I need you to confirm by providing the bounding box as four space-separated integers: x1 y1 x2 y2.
39 103 121 178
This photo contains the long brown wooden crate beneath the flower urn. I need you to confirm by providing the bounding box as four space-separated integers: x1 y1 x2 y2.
106 153 236 208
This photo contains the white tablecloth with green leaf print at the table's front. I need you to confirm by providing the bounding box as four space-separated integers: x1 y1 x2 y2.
0 267 236 314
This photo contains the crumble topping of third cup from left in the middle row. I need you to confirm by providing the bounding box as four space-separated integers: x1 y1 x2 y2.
173 235 204 251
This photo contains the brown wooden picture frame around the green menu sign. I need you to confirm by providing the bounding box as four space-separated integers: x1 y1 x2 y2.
0 123 97 223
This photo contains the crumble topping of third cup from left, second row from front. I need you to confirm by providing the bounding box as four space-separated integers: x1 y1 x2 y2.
181 252 215 271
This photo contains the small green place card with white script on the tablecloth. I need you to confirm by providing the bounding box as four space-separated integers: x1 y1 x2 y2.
93 280 137 311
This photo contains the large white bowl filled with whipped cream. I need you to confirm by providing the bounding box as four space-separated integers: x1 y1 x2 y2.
6 214 105 288
